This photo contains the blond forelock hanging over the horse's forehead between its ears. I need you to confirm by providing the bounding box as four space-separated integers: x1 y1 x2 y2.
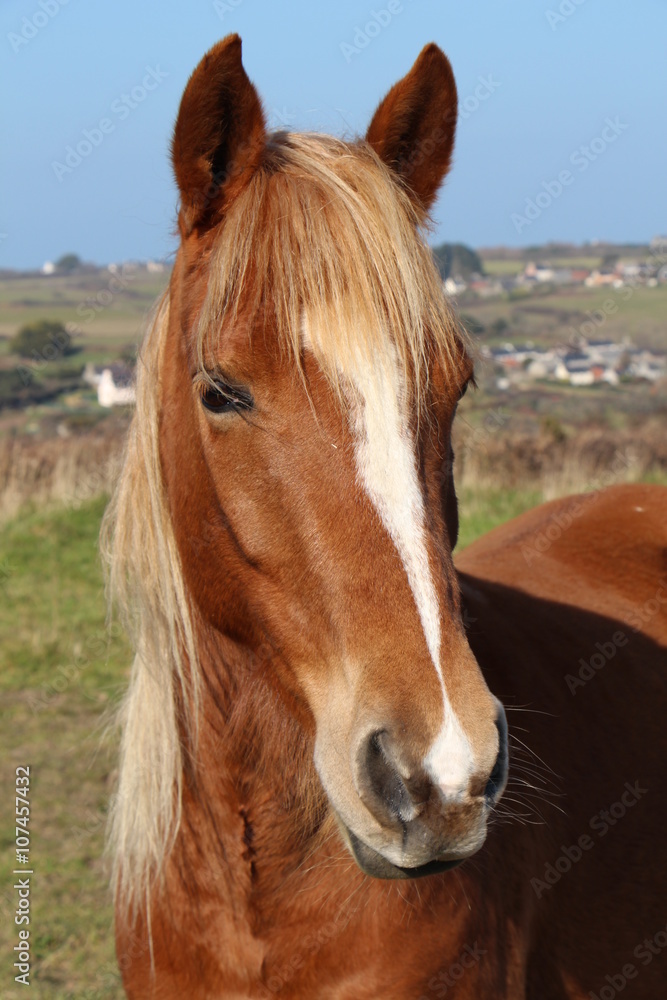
198 133 470 395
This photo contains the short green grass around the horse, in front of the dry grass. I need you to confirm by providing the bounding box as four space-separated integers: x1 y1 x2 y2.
0 484 537 1000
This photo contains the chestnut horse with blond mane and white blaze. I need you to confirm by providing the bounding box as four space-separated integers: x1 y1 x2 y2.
102 35 667 1000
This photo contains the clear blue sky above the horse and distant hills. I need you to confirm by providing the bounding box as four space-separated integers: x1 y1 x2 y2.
0 0 667 268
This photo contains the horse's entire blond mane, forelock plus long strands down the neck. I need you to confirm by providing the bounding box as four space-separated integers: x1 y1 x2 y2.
101 134 468 906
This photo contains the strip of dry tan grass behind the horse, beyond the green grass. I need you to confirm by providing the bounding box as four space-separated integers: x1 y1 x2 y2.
0 415 667 522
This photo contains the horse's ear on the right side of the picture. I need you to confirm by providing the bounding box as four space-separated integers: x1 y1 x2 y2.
366 42 457 211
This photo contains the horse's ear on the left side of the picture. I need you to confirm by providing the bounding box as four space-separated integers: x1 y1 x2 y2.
171 35 266 236
